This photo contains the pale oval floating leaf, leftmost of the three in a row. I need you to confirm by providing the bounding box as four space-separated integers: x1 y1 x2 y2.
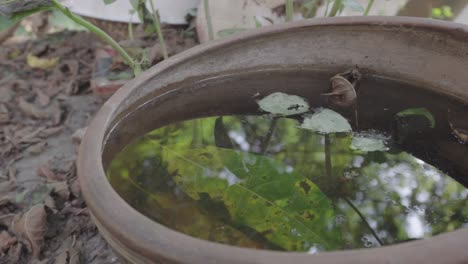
257 92 309 116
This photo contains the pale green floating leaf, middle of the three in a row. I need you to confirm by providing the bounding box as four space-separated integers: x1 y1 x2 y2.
300 108 352 134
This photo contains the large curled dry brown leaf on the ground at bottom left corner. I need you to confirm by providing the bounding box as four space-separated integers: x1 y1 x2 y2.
11 204 47 258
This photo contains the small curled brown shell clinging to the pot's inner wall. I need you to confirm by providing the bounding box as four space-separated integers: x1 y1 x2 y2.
322 75 357 108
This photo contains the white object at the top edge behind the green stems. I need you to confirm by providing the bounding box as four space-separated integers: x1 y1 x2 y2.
61 0 200 25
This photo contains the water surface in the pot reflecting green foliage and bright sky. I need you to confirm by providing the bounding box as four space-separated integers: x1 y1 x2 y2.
108 116 468 254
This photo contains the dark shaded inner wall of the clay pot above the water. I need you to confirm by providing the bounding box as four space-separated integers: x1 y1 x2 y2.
103 67 468 186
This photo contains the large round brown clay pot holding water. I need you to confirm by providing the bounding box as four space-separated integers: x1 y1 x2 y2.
78 17 468 264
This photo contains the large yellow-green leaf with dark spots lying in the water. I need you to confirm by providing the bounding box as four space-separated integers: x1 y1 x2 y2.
163 146 341 251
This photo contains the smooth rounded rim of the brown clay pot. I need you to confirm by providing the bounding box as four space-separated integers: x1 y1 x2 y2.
77 16 468 263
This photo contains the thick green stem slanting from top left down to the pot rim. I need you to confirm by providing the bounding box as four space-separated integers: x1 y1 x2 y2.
52 0 141 76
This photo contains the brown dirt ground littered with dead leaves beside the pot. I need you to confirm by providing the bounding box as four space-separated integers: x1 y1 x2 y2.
0 25 196 264
